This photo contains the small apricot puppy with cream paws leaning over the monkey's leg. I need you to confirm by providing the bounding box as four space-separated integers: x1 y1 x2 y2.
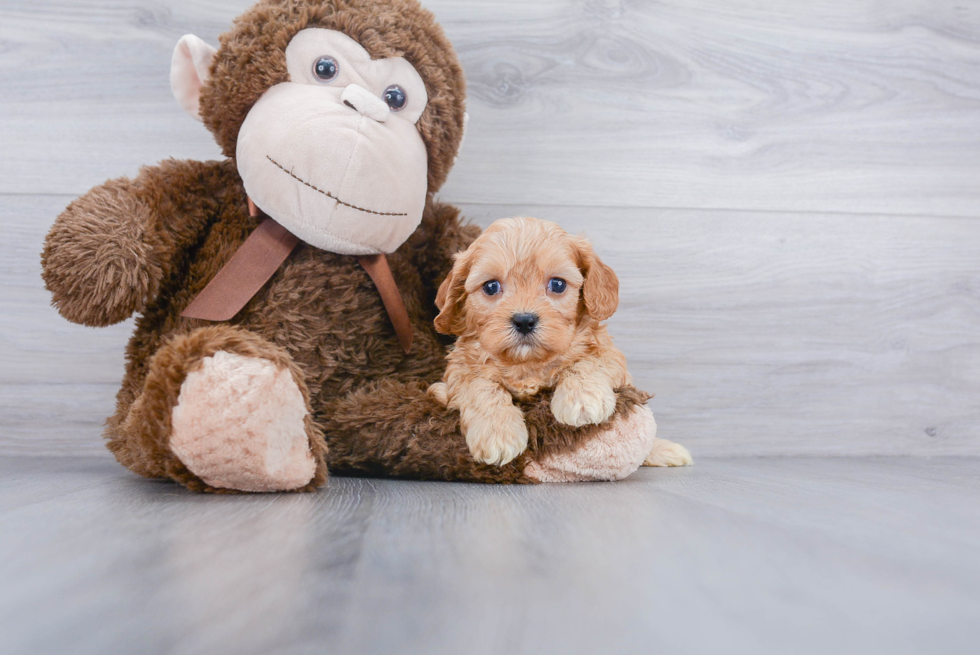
429 218 691 466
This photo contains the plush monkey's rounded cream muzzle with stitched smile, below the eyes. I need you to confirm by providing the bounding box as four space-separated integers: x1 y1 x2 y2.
236 82 427 255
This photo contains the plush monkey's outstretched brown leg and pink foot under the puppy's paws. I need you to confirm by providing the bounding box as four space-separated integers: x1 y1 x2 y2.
326 379 653 483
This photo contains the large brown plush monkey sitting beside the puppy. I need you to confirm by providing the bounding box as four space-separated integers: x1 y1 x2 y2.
36 0 668 491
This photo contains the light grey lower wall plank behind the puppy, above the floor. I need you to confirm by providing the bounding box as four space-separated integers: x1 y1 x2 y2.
0 196 980 457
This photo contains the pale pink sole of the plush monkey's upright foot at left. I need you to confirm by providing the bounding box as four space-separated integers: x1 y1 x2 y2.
170 350 316 491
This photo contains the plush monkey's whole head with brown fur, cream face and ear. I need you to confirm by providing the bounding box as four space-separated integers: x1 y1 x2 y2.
170 0 465 255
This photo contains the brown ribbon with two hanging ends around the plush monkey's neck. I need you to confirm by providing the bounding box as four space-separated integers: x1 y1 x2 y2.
180 198 412 353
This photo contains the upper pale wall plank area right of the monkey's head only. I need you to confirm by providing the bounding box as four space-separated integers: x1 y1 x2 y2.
440 0 980 216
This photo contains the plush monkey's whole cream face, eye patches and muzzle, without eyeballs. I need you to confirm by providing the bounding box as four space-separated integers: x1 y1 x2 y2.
236 28 428 255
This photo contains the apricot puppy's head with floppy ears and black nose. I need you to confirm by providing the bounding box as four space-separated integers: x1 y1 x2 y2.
435 218 619 362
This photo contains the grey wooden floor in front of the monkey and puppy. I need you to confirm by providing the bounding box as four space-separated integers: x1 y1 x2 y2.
0 457 980 655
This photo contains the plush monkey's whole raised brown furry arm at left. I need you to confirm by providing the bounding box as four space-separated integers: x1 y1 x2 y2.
41 160 242 327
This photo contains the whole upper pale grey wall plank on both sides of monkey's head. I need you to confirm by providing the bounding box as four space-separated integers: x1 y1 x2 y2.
0 0 980 217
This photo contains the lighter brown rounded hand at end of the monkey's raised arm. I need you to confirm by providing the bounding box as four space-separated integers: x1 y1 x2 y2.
41 178 162 327
